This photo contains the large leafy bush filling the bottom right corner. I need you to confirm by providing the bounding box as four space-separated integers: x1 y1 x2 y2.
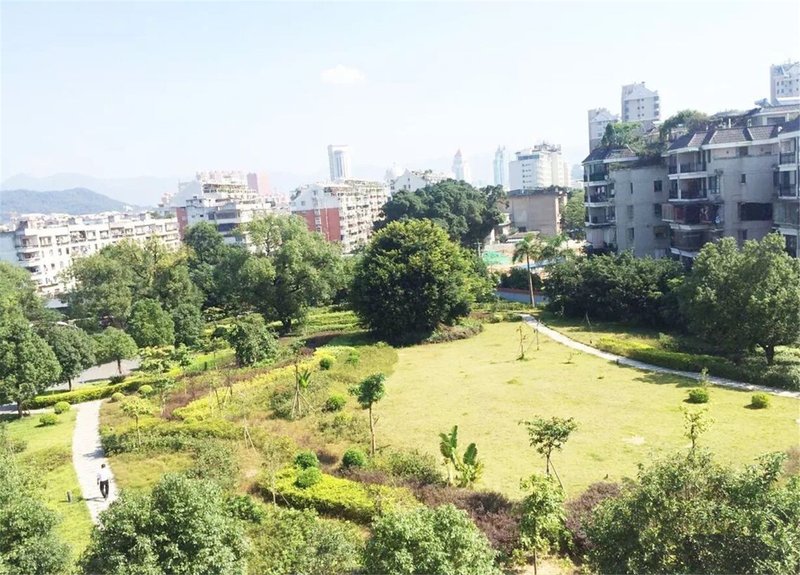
585 451 800 574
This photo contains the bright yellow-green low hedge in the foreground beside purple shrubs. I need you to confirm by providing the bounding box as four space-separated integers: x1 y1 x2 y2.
258 468 419 525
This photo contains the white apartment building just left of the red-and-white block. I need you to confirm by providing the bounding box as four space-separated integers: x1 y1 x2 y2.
176 179 273 245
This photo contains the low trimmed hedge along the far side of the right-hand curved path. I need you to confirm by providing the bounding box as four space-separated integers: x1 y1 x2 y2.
596 337 800 390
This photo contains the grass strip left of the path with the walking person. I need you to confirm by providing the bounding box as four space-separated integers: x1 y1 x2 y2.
8 411 92 559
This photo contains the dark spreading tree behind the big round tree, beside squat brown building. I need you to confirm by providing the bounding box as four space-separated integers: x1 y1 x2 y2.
375 180 505 249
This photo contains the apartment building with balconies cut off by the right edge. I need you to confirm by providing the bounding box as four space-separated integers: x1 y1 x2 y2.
773 118 800 258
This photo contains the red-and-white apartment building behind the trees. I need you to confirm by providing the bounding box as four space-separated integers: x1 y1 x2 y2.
291 180 389 253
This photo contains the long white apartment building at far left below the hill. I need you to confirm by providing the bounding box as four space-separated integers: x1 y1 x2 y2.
0 213 180 297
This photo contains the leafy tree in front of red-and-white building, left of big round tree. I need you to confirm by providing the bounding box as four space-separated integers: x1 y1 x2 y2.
238 215 341 332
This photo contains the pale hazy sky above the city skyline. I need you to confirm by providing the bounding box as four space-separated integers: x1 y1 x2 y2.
0 0 800 184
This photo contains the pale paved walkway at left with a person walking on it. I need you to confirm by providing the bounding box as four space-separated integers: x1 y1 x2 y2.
72 400 117 523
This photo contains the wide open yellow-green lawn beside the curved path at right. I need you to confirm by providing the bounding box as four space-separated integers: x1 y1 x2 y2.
376 323 800 496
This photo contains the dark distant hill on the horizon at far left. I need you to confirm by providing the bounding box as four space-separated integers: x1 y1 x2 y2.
0 188 136 220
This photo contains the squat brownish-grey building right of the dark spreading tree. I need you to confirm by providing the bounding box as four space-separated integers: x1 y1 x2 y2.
507 186 569 236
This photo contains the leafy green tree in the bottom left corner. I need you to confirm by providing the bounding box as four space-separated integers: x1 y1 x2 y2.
0 427 69 575
